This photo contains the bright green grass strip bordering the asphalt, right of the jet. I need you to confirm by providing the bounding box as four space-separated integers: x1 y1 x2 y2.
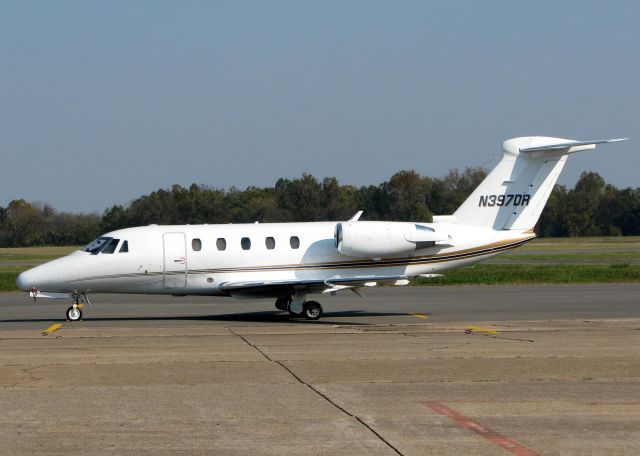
412 264 640 285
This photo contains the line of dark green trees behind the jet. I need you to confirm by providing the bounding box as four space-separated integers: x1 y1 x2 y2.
0 168 640 247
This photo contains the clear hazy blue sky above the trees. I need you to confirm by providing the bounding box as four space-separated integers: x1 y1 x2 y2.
0 0 640 212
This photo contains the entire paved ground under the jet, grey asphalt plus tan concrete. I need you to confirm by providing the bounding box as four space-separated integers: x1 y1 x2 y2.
0 285 640 456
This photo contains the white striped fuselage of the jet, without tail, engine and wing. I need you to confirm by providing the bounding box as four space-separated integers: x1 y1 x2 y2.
18 222 534 297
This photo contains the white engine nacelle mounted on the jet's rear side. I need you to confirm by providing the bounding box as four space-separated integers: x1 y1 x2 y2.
334 221 450 258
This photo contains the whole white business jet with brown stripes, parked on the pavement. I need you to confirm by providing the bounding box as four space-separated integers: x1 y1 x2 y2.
17 136 627 321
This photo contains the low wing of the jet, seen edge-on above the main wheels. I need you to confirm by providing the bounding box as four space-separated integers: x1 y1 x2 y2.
221 275 430 298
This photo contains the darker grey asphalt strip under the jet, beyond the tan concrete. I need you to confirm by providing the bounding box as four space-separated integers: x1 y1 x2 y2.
0 284 640 330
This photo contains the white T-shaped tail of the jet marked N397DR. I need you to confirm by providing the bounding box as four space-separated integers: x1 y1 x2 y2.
453 136 628 231
